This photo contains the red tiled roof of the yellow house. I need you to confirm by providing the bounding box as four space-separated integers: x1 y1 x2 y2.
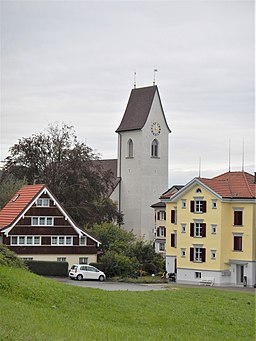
199 172 256 199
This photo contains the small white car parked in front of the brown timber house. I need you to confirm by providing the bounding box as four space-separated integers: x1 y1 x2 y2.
68 264 106 282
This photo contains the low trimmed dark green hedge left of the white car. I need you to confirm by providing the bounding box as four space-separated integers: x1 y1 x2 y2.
25 260 68 277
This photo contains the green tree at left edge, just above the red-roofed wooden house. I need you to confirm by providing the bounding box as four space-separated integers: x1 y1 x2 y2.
0 175 27 210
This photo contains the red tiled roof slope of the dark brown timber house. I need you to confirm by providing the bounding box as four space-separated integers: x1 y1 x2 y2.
0 185 45 230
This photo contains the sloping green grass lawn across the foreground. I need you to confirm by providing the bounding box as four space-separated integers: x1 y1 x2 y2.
0 266 255 341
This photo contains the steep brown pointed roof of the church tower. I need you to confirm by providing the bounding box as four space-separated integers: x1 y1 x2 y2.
116 85 170 133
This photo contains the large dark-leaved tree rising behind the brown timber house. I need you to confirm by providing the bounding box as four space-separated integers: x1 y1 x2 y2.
1 124 122 226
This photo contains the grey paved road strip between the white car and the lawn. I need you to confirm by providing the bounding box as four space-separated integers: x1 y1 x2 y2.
51 277 170 291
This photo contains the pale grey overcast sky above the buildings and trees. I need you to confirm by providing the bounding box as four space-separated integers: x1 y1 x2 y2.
1 0 255 186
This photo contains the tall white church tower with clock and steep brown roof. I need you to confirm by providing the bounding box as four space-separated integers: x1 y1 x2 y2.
116 85 170 240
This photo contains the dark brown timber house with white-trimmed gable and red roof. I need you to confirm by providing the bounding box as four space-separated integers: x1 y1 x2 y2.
0 184 100 265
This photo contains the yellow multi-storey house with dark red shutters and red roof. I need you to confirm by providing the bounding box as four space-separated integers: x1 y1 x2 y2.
161 172 256 286
